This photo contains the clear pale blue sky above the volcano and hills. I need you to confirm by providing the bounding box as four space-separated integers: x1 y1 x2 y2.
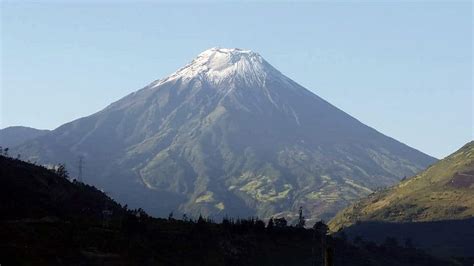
0 1 474 158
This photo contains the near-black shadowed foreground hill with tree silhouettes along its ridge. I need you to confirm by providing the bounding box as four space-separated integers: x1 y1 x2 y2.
0 156 457 266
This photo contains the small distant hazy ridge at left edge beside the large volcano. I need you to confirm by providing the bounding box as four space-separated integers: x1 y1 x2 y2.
0 126 49 148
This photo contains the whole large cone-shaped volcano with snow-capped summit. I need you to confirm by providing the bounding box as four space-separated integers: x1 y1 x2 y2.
13 48 435 219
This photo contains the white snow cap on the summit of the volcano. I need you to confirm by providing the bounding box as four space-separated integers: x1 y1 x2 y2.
157 47 279 85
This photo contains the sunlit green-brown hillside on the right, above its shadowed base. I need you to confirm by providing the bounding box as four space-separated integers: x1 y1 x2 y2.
329 141 474 231
